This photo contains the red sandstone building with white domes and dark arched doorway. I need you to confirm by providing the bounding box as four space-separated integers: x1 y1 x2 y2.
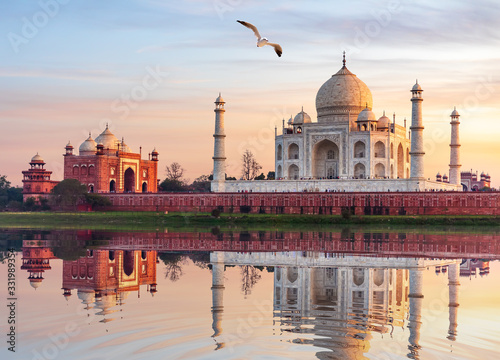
64 126 158 193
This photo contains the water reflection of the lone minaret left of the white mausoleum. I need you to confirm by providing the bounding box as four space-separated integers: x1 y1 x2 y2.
210 251 225 350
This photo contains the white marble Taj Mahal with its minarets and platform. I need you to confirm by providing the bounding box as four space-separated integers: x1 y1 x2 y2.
212 55 462 192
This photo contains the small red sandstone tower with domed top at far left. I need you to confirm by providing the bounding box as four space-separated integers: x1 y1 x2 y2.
23 153 59 200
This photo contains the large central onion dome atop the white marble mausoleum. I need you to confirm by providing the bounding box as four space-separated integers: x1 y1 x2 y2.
316 64 373 122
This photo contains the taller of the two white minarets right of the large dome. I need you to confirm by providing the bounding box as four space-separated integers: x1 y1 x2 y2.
410 80 425 179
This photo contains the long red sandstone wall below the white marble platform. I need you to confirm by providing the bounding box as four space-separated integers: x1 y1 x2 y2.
103 191 500 215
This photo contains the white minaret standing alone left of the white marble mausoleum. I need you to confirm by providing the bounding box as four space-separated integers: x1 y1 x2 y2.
211 93 226 192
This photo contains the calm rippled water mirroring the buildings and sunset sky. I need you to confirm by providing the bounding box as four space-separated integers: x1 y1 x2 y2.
0 229 500 360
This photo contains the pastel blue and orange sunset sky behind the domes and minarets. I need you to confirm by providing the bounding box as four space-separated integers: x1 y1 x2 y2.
0 0 500 187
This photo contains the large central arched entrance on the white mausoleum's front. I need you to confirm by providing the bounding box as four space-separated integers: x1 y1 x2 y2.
312 140 339 179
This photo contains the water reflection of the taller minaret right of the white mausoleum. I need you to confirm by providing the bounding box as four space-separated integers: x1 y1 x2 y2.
408 268 424 359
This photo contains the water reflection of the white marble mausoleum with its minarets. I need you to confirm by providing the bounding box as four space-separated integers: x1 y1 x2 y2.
211 252 488 359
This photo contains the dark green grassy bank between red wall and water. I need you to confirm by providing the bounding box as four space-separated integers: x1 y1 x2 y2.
0 212 500 231
